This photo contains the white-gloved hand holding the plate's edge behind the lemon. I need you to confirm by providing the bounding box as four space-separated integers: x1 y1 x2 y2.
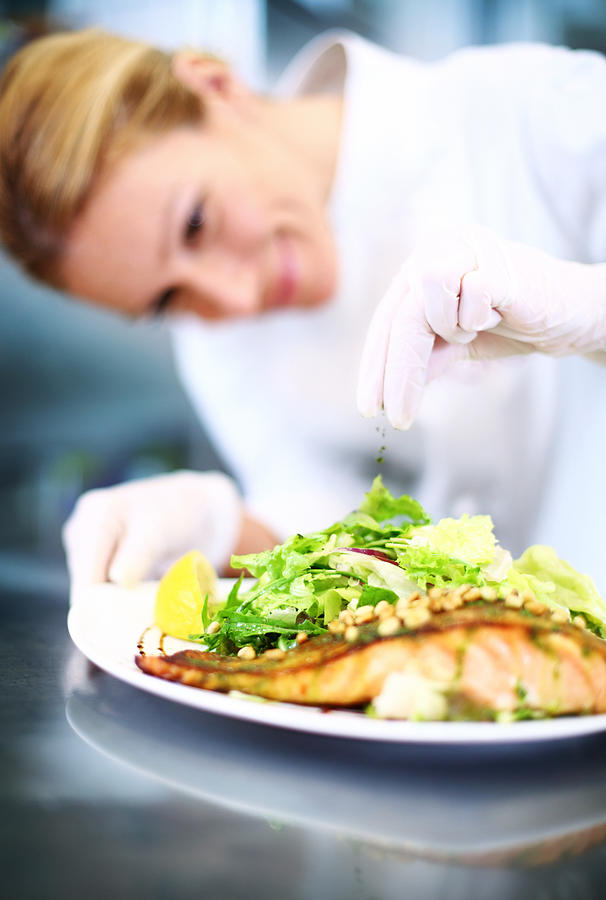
63 472 243 595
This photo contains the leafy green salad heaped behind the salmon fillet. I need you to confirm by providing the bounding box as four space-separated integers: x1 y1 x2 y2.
196 476 606 655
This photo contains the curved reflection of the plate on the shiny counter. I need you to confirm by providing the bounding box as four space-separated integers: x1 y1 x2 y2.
66 654 606 866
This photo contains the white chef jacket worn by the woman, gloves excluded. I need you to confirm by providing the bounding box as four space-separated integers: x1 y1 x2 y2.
172 34 606 576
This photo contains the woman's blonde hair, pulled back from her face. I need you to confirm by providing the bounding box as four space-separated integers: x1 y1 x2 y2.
0 29 203 287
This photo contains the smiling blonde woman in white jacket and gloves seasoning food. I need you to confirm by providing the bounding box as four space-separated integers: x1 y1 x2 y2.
0 30 606 585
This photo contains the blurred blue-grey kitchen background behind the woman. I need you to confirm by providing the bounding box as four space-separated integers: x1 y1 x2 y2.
0 0 606 592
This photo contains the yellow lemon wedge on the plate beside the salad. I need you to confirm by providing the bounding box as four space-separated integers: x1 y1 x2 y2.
154 550 217 640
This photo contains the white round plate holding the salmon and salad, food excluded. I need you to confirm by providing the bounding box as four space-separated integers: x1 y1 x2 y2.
67 581 606 744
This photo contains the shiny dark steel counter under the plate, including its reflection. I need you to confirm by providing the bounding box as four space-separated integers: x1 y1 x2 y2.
0 584 606 900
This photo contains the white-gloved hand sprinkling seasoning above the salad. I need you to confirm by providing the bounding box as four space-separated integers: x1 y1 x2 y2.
357 226 606 428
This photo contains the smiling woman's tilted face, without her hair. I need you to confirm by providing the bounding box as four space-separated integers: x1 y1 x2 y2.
62 82 336 319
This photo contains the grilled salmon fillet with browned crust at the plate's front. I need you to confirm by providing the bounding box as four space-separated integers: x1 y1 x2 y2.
136 603 606 719
